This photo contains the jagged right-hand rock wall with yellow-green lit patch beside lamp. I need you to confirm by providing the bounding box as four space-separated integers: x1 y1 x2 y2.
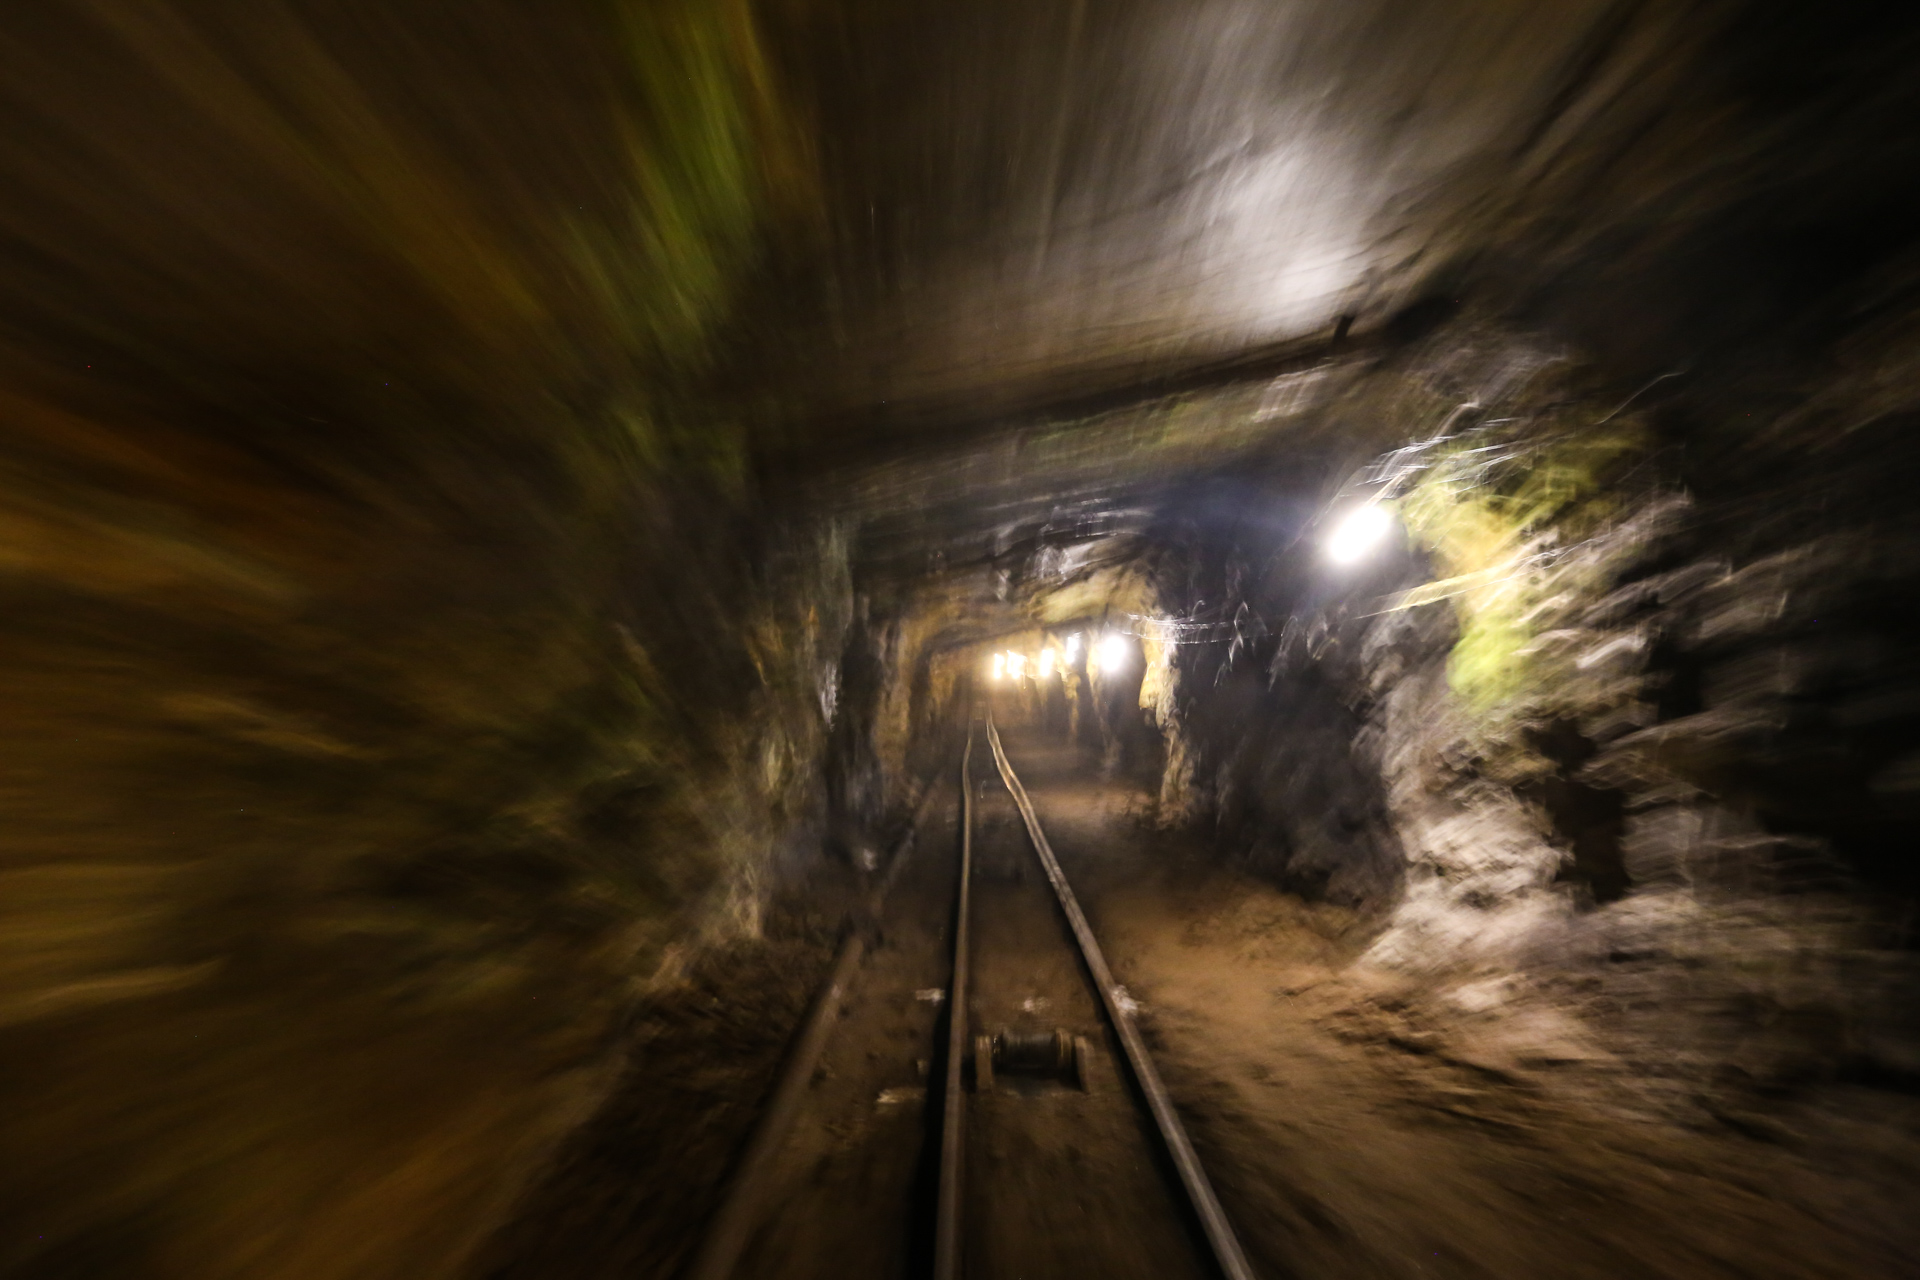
1152 328 1920 1123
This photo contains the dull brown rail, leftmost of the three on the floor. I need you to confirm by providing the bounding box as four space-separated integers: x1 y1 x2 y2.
685 787 933 1280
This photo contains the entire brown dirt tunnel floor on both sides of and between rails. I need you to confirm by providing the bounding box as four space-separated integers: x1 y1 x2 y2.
483 733 1920 1280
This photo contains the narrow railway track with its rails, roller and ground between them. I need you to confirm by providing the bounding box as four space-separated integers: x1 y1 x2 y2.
684 716 1252 1280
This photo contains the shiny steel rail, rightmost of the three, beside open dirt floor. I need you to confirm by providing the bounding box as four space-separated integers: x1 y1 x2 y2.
990 714 1254 1280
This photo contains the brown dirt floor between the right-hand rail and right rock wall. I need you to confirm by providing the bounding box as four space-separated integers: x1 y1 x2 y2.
1008 737 1920 1280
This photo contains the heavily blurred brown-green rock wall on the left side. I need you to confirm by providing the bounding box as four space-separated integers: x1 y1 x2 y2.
0 0 852 1280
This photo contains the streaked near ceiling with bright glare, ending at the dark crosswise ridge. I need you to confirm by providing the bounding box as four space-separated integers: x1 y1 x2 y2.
753 0 1916 443
